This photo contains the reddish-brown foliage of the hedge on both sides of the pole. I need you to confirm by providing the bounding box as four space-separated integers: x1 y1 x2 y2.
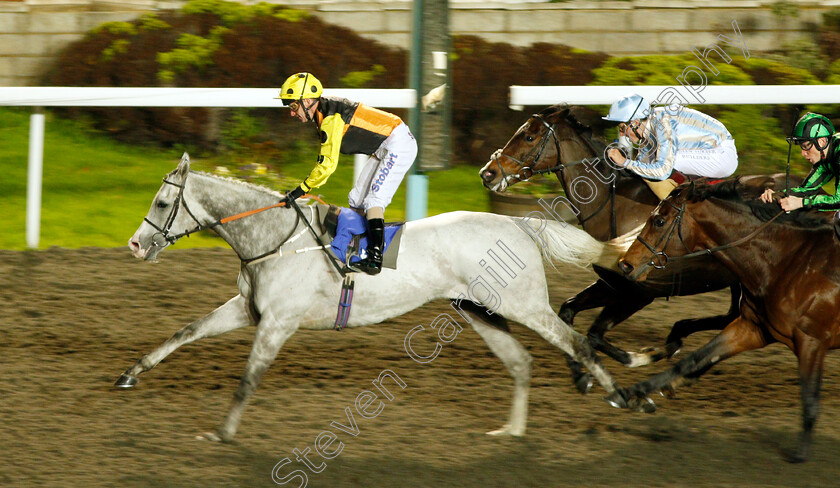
43 7 607 164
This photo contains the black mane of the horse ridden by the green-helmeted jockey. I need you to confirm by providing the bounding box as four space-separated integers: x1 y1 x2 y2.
675 176 833 230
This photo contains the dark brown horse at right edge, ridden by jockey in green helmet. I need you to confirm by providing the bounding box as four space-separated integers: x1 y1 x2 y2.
608 178 840 461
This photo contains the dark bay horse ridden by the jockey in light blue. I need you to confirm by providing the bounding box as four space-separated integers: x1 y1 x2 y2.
479 103 798 393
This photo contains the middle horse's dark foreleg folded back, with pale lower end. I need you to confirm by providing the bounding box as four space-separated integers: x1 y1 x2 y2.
586 294 661 368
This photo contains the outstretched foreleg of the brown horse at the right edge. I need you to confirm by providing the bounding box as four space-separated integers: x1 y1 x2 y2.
607 317 772 407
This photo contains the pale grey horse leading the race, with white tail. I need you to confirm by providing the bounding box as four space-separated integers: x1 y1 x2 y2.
116 154 644 440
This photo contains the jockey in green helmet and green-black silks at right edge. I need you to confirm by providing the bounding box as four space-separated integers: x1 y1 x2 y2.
761 112 840 212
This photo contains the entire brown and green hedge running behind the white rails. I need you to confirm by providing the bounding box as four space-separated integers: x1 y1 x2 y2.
44 0 840 177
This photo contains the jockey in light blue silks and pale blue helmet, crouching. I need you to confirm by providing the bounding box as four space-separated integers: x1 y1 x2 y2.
602 95 738 199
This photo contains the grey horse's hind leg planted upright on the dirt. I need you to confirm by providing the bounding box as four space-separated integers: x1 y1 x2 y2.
470 314 531 436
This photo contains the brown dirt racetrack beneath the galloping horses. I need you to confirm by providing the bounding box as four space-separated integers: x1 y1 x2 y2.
0 248 840 488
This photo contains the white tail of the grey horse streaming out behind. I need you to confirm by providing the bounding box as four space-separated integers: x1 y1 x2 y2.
517 219 641 270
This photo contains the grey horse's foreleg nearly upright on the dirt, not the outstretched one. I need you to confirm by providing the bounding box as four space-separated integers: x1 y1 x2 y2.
204 312 297 441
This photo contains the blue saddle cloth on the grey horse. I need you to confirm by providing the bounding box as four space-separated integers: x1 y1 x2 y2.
324 205 405 269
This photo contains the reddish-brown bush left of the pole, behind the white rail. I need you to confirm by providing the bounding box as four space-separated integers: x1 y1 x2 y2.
43 8 406 149
